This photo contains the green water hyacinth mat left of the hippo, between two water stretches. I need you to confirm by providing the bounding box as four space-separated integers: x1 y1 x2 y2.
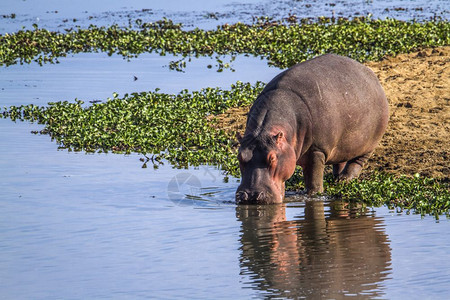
0 82 264 173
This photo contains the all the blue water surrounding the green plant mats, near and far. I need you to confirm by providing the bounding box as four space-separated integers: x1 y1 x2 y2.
0 0 450 299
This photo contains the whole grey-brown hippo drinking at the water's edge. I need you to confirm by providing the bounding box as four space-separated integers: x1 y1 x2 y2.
236 54 389 204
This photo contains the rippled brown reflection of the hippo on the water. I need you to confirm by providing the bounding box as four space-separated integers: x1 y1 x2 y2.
236 200 391 299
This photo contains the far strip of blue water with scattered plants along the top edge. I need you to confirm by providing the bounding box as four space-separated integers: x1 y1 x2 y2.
0 0 450 33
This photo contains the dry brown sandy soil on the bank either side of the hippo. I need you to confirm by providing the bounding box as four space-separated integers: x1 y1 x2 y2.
216 47 450 180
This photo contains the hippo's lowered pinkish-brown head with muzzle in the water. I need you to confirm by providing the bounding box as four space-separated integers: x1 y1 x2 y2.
236 131 296 204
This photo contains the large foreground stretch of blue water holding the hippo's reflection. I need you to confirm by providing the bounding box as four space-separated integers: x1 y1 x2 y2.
0 120 450 299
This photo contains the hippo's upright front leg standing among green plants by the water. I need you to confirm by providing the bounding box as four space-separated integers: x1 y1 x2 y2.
302 151 325 195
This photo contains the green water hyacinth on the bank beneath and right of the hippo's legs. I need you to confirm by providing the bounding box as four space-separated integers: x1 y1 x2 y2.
286 167 450 219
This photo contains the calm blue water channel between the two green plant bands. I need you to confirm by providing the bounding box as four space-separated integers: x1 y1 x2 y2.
0 53 280 106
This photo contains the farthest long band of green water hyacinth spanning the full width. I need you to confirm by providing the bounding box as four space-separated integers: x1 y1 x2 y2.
0 18 450 69
